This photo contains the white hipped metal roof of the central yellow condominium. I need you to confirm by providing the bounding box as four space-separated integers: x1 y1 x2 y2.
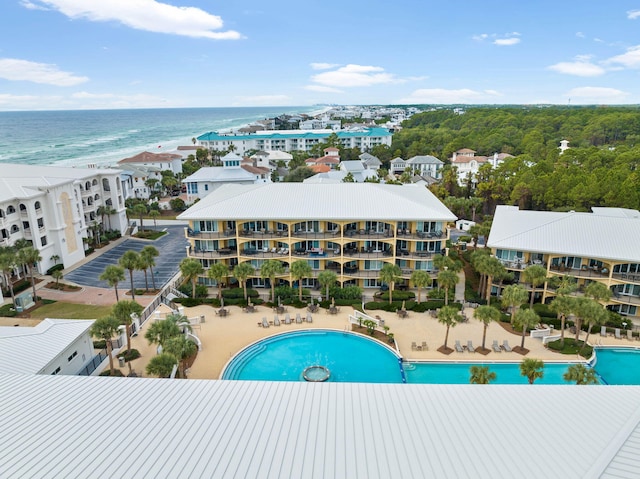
178 183 456 221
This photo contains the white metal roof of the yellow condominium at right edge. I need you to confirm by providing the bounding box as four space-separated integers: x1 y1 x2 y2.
487 205 640 263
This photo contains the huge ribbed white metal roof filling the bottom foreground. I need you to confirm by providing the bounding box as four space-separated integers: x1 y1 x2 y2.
0 375 640 479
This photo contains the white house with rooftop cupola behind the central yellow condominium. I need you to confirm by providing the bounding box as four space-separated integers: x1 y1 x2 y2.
182 152 271 203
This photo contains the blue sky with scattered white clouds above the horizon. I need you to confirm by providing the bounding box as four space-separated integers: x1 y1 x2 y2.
0 0 640 110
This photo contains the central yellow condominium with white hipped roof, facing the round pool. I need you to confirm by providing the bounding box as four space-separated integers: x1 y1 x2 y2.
179 183 456 288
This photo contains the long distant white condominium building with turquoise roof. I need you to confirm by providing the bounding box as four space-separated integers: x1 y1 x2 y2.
198 128 392 155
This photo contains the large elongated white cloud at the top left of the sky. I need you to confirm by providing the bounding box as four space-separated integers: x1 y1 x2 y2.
25 0 242 40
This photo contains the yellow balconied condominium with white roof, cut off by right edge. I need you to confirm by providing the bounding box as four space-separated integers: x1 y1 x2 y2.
487 206 640 318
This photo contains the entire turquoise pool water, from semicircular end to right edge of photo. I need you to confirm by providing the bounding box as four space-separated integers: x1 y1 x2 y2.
221 330 640 385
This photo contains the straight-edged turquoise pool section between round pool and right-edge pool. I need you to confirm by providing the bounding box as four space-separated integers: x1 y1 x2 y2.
404 363 584 384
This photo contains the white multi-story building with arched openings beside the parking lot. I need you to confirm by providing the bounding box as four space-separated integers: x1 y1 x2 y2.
0 164 127 273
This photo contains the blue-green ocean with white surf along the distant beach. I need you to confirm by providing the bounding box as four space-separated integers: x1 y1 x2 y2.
0 106 320 167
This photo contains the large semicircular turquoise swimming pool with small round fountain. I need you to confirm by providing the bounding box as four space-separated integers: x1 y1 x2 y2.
221 330 403 383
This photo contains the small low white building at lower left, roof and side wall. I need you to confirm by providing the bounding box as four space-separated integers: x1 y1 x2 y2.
0 318 96 375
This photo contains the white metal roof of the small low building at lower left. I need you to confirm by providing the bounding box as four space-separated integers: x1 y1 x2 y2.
0 318 94 376
